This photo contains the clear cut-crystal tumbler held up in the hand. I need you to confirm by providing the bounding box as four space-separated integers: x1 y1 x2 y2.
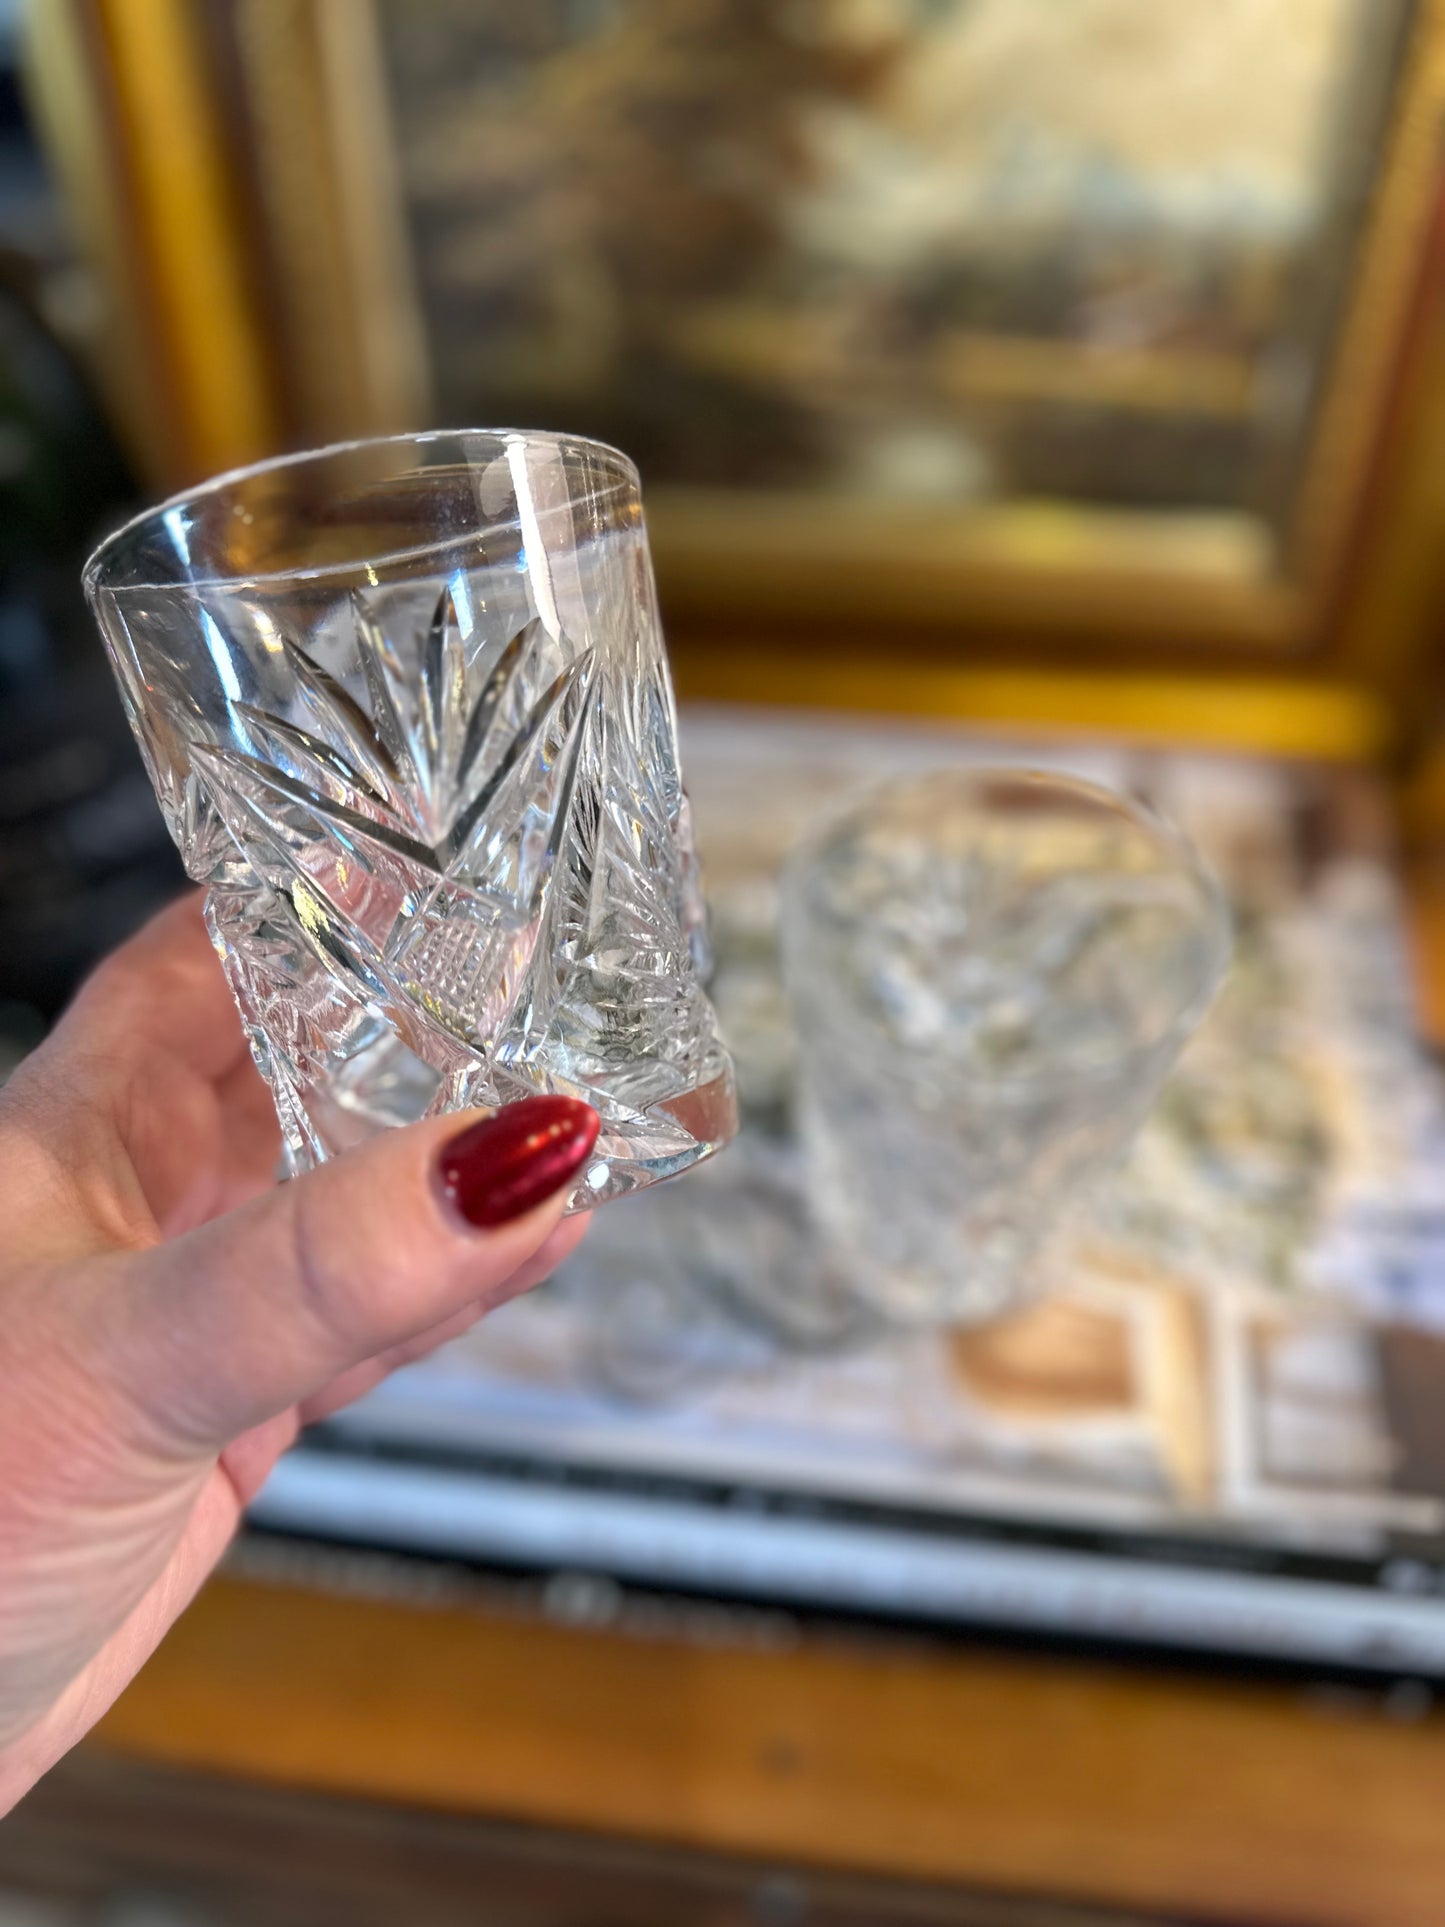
85 432 736 1206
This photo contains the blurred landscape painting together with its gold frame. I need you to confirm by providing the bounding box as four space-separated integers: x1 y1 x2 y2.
25 0 1445 728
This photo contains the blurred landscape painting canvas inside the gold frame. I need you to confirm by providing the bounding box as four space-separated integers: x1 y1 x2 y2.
378 0 1408 528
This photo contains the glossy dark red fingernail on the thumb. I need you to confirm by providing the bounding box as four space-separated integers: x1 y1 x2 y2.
437 1096 599 1227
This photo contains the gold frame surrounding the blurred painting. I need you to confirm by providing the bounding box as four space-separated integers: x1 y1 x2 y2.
19 0 1445 753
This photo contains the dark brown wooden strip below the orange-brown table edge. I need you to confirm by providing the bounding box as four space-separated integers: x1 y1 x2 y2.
0 1752 1202 1927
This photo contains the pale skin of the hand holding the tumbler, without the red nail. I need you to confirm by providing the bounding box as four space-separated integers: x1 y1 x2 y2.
0 898 582 1815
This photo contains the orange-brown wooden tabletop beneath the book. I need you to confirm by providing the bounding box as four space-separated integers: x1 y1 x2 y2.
56 867 1445 1927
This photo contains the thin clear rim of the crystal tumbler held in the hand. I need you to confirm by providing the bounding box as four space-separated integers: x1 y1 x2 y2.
81 428 642 603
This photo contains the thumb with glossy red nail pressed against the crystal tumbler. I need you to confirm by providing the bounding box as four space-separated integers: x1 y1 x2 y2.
89 1096 597 1451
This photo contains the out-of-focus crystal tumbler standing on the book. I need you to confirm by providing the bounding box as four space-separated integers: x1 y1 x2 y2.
784 769 1229 1322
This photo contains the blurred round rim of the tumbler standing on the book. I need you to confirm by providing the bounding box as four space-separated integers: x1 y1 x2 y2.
782 763 1233 1093
